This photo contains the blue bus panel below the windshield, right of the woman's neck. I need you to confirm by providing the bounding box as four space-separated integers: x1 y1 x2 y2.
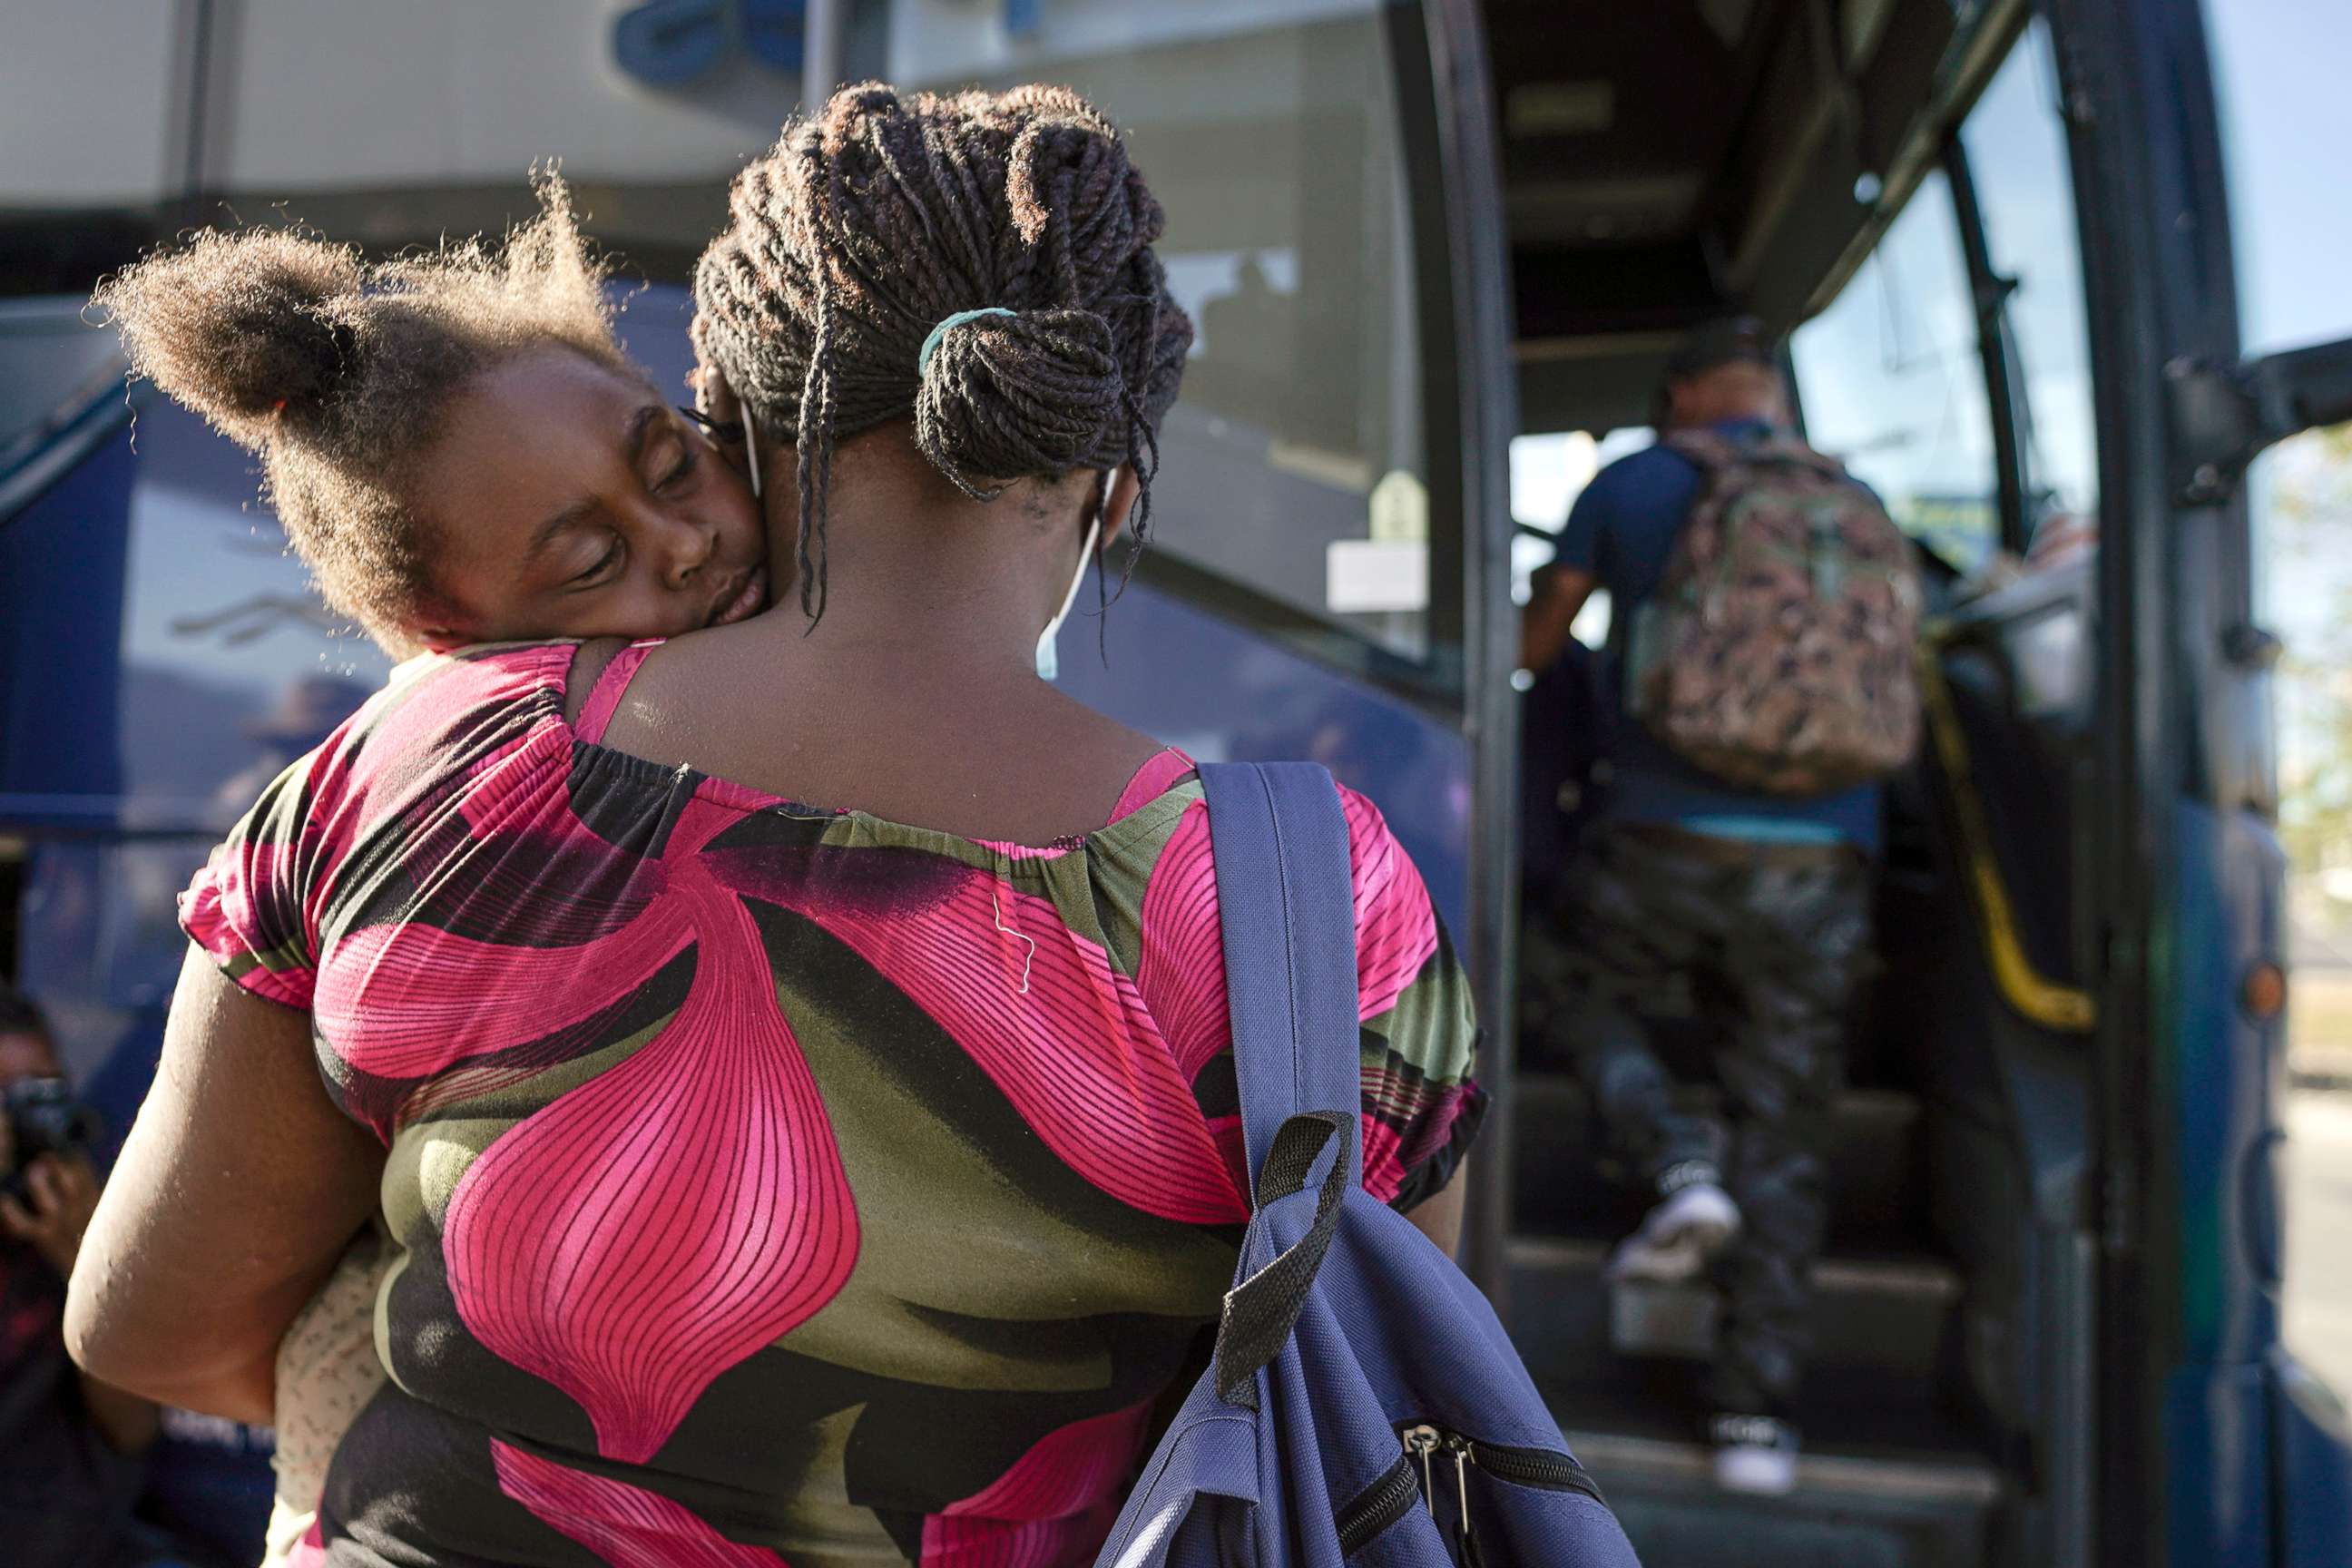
1056 585 1470 940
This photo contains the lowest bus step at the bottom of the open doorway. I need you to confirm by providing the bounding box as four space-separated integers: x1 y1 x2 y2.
1562 1417 2002 1568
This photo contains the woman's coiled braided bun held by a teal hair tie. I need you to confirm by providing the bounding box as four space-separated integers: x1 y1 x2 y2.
915 310 1127 501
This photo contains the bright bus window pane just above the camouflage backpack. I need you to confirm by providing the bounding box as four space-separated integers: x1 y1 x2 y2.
1790 170 1999 572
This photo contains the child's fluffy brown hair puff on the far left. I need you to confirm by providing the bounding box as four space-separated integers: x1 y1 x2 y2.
94 228 362 446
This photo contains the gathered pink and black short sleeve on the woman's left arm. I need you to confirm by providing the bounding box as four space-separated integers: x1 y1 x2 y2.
179 743 331 1008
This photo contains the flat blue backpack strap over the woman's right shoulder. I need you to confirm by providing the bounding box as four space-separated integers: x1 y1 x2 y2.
1200 761 1364 1203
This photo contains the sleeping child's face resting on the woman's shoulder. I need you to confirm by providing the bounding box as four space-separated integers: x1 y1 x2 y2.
412 348 769 646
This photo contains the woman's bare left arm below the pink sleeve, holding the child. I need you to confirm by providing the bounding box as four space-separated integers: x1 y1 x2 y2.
66 950 383 1422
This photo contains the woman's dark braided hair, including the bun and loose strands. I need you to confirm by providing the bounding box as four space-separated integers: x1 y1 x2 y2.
694 83 1192 618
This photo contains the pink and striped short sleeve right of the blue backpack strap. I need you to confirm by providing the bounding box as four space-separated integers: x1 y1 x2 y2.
1340 789 1486 1210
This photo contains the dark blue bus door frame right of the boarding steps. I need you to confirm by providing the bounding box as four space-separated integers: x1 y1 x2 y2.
2049 0 2352 1563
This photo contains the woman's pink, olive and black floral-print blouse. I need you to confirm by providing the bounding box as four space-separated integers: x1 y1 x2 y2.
183 644 1482 1568
